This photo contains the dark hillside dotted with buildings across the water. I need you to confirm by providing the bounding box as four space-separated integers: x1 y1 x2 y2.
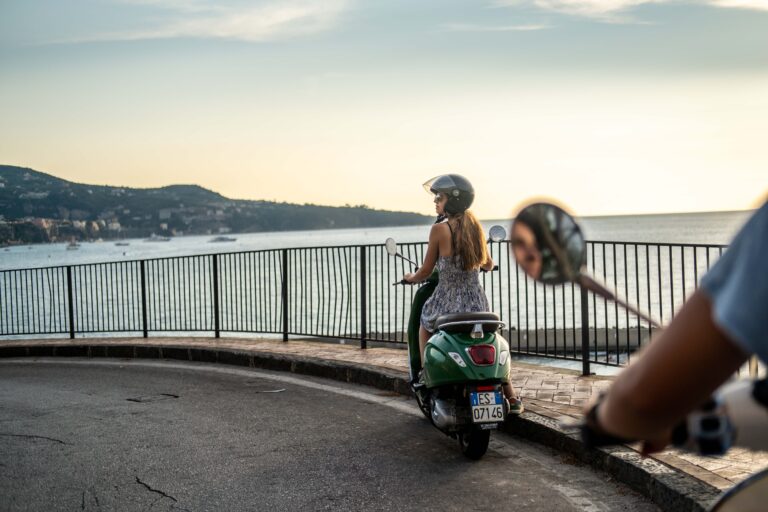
0 165 430 243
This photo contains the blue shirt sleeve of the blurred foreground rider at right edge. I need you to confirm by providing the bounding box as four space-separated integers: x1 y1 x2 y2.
701 202 768 362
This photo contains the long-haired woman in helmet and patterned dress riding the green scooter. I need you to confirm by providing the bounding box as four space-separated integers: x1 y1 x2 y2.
403 174 523 414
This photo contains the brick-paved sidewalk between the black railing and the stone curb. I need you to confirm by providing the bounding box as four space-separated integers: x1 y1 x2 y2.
0 337 768 489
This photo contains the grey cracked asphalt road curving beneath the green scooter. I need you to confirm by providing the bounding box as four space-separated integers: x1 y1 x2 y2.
0 359 656 512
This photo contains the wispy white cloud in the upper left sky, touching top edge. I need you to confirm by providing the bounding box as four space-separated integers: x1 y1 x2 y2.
58 0 347 43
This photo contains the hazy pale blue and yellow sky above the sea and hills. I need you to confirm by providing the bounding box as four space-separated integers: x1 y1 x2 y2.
0 0 768 218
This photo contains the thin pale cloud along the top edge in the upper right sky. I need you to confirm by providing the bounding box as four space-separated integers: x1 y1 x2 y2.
495 0 768 22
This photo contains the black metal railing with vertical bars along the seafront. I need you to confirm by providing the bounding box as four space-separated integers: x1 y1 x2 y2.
0 241 726 373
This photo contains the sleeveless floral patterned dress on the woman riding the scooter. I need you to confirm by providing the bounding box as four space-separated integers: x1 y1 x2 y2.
421 256 489 332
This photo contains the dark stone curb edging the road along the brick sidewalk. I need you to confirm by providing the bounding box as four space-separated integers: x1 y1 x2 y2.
0 344 720 512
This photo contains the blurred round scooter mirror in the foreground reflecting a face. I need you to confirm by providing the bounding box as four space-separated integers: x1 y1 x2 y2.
512 203 587 284
